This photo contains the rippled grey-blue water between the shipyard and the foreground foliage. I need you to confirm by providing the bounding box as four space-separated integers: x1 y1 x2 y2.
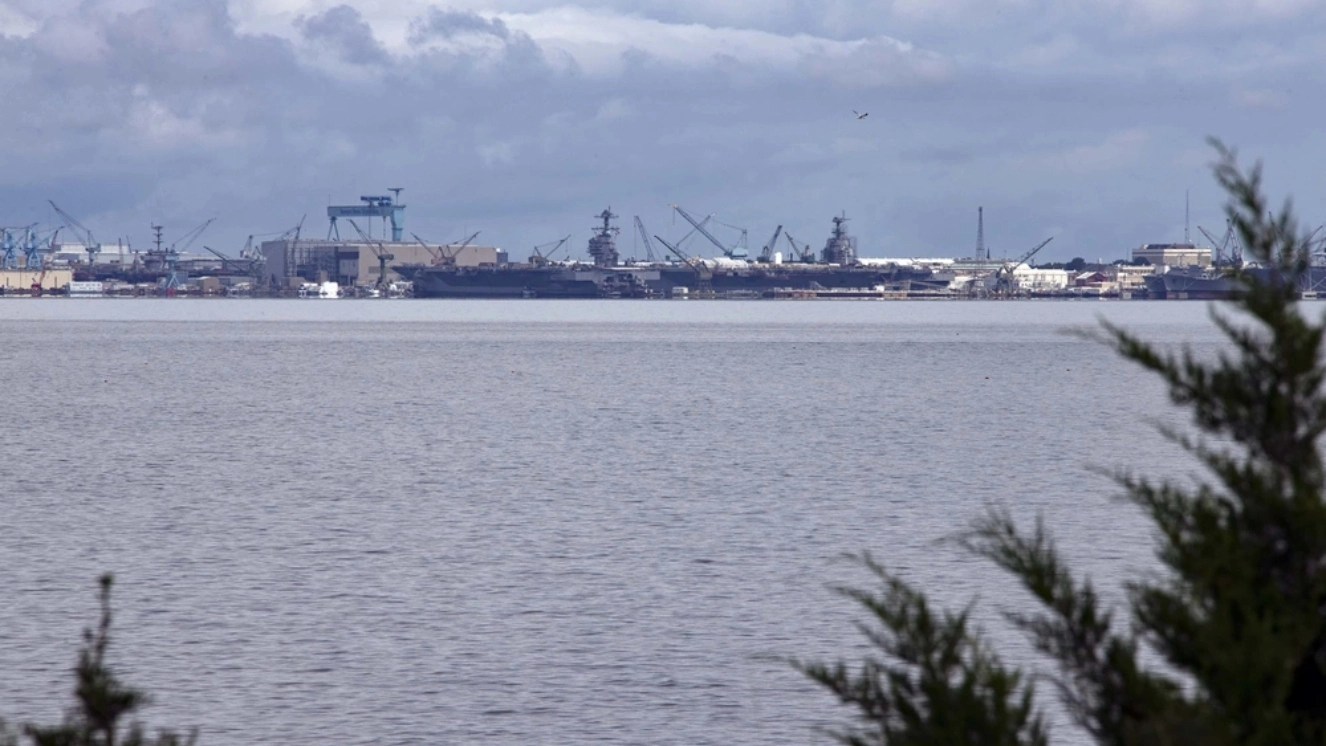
0 299 1235 745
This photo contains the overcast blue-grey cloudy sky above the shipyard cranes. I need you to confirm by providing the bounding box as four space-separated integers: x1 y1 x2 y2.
0 0 1326 260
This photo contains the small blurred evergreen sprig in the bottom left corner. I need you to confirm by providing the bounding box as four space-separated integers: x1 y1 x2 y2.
0 575 198 746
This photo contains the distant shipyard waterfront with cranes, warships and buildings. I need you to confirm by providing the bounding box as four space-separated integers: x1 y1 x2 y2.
0 189 1326 299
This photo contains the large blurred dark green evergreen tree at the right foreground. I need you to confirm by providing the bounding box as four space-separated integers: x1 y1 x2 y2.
794 140 1326 746
